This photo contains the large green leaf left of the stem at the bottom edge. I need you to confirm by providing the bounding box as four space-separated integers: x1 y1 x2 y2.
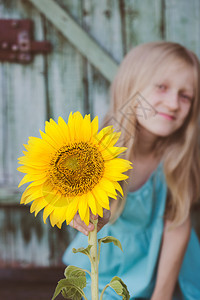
52 266 86 300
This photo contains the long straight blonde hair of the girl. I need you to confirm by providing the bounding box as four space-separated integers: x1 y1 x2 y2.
104 41 200 225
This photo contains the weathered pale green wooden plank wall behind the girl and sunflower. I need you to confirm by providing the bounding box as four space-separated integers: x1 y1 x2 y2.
0 0 200 267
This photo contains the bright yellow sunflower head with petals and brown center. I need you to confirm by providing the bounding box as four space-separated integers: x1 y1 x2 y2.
18 112 131 228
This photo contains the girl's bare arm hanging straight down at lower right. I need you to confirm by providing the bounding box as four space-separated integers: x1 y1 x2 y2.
151 217 191 300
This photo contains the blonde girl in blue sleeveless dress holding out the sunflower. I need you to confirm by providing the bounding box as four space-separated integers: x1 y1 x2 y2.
63 42 200 300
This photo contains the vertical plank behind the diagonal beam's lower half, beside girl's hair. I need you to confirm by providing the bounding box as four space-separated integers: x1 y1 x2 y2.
82 0 124 123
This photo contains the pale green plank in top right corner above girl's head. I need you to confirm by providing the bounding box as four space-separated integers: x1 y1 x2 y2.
165 0 200 58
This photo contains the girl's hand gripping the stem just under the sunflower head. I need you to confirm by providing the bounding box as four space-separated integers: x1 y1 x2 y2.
69 209 111 235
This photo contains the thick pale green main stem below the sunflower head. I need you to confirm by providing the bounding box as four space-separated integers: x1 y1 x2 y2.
88 219 99 300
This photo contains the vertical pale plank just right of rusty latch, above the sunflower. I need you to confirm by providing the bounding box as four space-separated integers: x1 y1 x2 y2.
45 1 87 121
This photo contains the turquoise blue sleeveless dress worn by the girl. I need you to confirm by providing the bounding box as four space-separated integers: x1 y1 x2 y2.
63 164 200 300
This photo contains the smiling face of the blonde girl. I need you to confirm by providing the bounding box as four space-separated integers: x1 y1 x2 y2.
137 63 194 137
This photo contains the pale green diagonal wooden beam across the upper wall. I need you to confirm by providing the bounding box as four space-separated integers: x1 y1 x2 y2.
28 0 118 81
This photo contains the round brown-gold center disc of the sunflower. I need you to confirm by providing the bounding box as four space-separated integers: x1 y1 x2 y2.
49 142 104 197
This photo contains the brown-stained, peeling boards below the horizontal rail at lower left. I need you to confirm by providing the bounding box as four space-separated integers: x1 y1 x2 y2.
0 206 76 268
